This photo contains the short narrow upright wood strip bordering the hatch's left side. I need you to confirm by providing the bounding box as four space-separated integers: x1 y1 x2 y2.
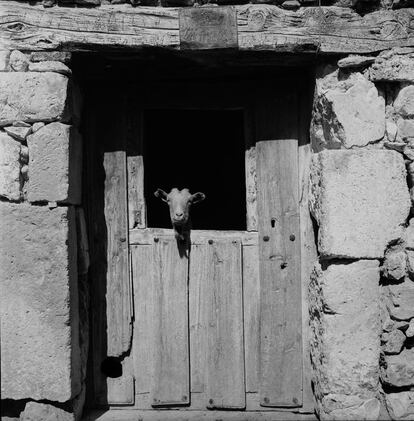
127 155 147 229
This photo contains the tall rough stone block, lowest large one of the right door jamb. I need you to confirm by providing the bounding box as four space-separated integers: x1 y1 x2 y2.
309 260 381 419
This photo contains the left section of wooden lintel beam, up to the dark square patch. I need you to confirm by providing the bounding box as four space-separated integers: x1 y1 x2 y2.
0 1 179 51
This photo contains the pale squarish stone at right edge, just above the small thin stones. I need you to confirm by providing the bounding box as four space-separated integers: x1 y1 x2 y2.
387 279 414 320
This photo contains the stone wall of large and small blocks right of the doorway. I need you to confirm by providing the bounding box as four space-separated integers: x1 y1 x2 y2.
309 48 414 420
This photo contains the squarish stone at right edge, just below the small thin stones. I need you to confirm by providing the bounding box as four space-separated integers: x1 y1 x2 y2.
381 348 414 387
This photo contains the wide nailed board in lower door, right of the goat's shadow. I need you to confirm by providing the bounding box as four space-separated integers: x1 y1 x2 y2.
206 240 246 409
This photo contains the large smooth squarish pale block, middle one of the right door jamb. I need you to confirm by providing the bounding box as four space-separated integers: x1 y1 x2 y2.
310 150 410 258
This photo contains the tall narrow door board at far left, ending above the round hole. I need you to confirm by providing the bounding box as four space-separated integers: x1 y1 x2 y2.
103 151 132 357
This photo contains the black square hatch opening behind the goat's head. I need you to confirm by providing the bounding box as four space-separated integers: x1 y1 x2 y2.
144 110 246 230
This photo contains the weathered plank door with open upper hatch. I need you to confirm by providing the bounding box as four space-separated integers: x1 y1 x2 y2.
85 78 311 411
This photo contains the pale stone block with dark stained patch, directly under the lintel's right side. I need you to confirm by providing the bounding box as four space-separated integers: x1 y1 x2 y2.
311 73 385 151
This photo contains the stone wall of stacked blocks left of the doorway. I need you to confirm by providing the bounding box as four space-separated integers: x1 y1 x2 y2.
0 51 88 420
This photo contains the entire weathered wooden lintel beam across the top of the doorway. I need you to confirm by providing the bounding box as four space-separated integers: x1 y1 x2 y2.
0 1 414 54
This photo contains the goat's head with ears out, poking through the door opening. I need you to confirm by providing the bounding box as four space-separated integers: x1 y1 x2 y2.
154 188 206 241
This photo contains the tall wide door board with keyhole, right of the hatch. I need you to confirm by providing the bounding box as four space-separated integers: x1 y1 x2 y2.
256 138 302 407
